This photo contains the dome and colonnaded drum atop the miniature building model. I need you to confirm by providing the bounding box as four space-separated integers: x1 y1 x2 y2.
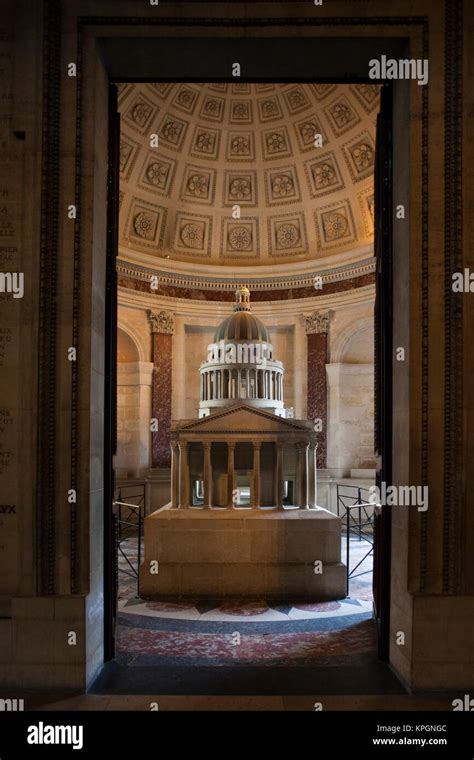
199 287 285 417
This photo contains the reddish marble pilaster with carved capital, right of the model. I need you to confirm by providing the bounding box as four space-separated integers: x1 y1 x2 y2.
304 311 329 467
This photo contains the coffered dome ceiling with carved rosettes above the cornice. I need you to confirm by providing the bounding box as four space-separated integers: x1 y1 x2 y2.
119 83 379 268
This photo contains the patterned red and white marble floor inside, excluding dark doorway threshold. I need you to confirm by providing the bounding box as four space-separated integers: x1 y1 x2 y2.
116 539 375 667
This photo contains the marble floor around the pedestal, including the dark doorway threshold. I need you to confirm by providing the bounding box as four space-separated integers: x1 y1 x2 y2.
88 537 396 693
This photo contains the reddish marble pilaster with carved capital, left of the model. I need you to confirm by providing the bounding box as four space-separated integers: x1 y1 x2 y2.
148 310 174 467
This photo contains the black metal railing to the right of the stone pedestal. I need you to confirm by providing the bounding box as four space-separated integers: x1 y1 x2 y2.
336 483 375 595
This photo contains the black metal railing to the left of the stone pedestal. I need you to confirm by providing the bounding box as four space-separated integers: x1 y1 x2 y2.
113 483 146 597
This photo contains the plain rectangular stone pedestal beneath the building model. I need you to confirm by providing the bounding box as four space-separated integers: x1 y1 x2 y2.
140 506 345 601
